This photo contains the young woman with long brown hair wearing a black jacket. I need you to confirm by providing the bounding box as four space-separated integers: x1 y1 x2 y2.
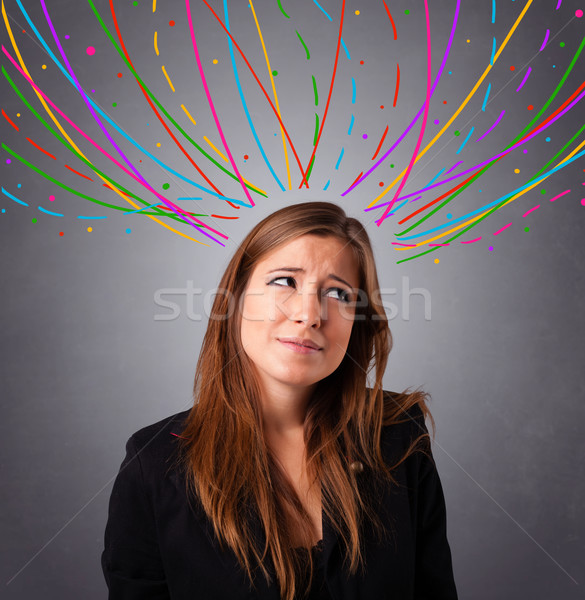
102 202 457 600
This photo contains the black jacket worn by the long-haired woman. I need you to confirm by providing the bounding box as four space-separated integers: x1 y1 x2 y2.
102 394 457 600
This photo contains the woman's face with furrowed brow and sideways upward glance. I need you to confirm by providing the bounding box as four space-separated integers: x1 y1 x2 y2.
241 234 359 393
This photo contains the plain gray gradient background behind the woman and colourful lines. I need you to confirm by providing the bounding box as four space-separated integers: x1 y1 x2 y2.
0 0 585 600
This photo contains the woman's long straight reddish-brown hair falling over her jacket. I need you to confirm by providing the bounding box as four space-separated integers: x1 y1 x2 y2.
179 202 428 600
